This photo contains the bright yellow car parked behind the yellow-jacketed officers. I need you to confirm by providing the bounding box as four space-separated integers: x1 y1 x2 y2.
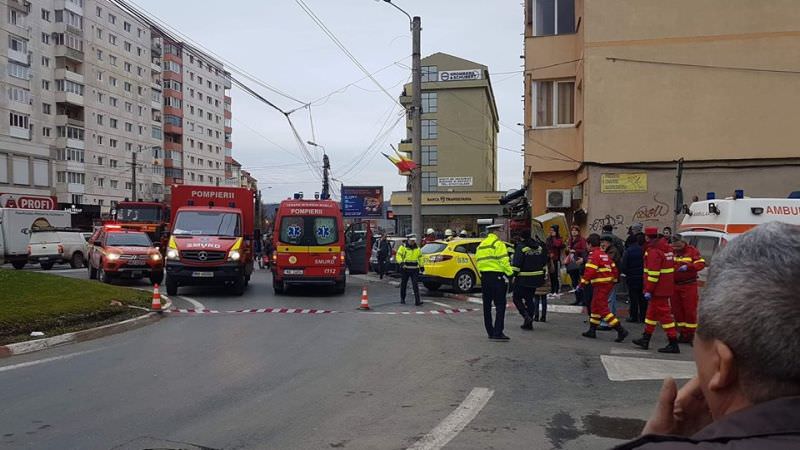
421 238 514 293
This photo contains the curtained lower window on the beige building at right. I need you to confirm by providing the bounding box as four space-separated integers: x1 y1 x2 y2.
533 80 575 127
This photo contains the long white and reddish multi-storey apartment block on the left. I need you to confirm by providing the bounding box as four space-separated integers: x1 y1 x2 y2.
0 0 238 216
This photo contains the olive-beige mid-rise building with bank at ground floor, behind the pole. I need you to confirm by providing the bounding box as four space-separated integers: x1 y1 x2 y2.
391 53 503 233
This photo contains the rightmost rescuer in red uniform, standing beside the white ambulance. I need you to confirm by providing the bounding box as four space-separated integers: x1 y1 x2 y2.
671 234 706 344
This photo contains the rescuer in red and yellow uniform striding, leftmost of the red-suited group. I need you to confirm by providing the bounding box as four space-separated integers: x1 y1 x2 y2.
578 233 628 342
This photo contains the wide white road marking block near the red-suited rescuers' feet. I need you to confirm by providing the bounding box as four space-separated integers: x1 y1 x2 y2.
600 355 697 381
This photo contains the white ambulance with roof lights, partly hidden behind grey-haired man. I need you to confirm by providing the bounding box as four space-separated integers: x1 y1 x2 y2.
678 196 800 281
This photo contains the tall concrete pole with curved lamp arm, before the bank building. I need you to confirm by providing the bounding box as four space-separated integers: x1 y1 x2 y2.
383 0 422 236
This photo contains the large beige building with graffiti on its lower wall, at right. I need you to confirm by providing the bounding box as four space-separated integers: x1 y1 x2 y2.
524 0 800 232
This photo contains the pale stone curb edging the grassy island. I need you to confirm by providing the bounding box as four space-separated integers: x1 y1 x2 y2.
0 302 172 358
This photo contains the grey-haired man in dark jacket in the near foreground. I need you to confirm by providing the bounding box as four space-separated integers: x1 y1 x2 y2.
616 222 800 450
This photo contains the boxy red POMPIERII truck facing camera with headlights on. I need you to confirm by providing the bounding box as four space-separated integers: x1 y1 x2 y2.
166 186 260 295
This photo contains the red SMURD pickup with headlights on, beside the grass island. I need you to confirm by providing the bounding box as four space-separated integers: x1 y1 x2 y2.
86 225 164 284
